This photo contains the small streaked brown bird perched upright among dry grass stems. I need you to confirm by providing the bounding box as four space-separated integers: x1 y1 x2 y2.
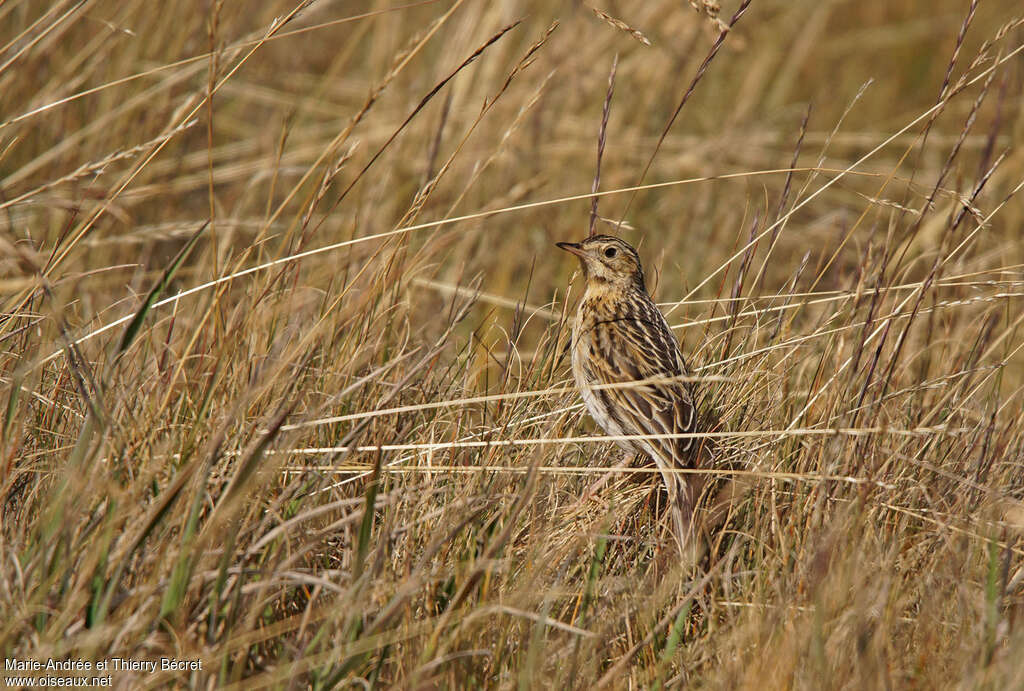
557 235 699 555
